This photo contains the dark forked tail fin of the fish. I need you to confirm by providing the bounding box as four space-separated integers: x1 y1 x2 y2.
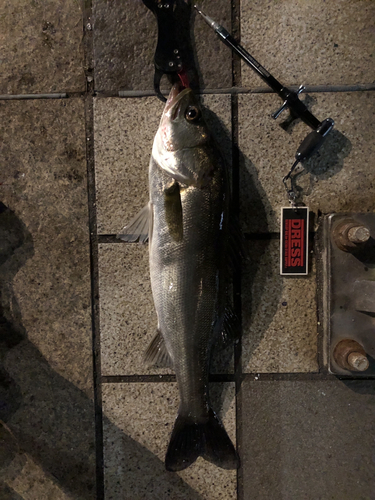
165 410 239 472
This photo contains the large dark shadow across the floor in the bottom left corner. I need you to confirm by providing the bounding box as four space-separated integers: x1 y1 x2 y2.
0 204 201 500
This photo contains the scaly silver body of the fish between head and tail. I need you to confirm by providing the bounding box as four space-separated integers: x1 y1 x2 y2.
150 154 227 422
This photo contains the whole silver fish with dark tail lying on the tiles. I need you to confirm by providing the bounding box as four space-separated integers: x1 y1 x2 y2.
118 84 239 472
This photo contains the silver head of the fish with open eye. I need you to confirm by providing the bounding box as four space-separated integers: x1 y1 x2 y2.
153 84 217 186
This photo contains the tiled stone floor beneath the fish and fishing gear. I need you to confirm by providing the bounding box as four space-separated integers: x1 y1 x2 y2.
0 0 375 500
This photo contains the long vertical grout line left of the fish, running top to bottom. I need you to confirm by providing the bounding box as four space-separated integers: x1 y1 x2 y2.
82 0 105 500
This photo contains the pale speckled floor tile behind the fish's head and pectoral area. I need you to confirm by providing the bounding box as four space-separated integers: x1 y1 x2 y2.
94 95 231 234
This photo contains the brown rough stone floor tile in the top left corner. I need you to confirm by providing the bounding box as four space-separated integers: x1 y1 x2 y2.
0 0 85 94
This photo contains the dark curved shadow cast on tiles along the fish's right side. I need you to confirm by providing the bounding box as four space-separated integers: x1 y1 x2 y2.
203 101 281 415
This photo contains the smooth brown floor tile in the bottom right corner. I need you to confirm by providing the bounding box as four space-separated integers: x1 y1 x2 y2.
241 378 375 500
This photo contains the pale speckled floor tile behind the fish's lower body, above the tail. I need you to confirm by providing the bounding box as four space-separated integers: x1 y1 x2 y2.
99 243 233 375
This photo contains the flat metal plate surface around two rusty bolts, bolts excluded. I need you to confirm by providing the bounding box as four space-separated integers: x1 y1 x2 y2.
321 213 375 377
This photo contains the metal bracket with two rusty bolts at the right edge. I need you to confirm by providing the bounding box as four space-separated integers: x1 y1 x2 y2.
321 213 375 377
